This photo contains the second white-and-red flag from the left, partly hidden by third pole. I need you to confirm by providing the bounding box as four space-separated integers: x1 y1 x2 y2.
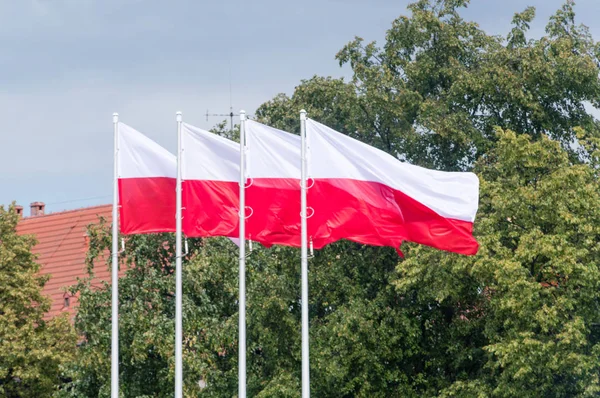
181 123 240 237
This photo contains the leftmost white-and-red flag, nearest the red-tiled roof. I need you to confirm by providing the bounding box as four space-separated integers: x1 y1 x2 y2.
117 122 177 234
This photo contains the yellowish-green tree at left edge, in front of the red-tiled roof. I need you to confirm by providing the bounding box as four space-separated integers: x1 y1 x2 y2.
0 205 76 397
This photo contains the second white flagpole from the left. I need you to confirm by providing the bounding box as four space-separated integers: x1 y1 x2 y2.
175 112 183 398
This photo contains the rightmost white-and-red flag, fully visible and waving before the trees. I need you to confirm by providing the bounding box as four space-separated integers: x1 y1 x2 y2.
306 119 479 255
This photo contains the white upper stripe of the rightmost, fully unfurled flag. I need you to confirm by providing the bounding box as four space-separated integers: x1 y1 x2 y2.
306 119 479 222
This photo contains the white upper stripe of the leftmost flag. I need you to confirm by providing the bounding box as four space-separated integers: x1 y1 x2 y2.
118 122 177 178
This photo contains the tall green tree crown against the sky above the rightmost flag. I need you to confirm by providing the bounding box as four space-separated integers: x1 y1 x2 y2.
257 0 600 170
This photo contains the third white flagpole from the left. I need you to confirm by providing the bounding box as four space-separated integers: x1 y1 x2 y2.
238 111 246 398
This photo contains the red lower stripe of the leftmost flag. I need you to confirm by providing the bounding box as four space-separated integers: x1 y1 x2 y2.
119 177 176 235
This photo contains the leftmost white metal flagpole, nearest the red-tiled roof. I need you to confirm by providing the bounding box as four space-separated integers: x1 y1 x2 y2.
110 113 119 398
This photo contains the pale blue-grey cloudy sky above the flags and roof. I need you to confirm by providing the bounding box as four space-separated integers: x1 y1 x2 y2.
0 0 600 215
